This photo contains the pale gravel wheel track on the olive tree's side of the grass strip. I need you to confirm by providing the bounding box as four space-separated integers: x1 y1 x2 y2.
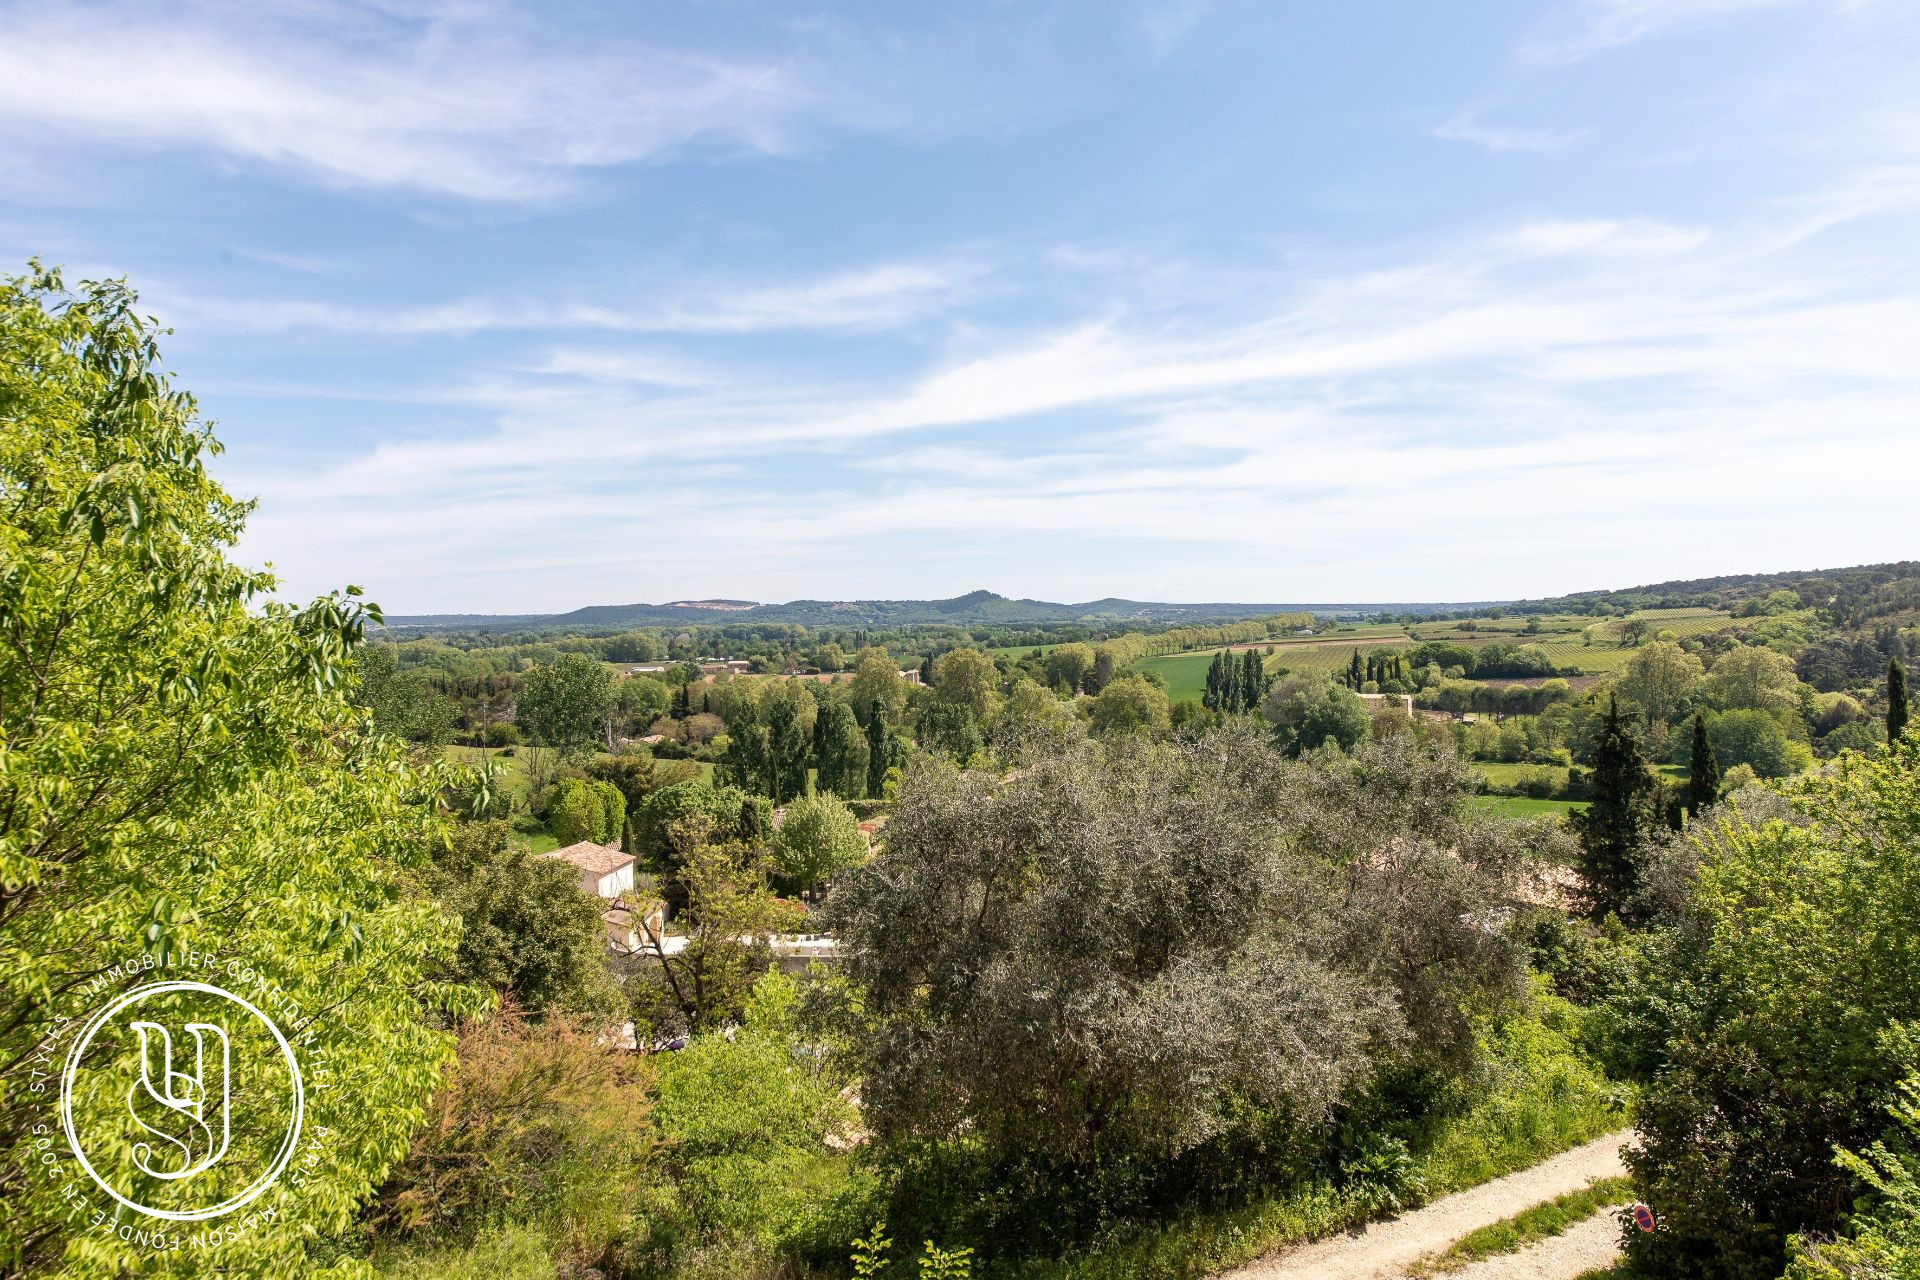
1219 1128 1634 1280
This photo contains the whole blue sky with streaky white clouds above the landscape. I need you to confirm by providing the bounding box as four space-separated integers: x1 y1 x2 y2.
0 0 1920 614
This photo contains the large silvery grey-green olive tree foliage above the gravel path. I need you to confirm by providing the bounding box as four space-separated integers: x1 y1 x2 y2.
828 725 1551 1159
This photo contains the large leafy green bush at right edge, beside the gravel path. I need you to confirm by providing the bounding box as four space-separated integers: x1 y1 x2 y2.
1628 735 1920 1280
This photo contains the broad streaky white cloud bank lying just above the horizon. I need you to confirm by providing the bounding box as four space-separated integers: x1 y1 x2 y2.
228 175 1920 610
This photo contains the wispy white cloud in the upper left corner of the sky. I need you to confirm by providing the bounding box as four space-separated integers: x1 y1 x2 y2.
0 4 829 200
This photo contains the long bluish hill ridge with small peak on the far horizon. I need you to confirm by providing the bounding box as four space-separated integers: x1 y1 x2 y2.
386 591 1492 631
